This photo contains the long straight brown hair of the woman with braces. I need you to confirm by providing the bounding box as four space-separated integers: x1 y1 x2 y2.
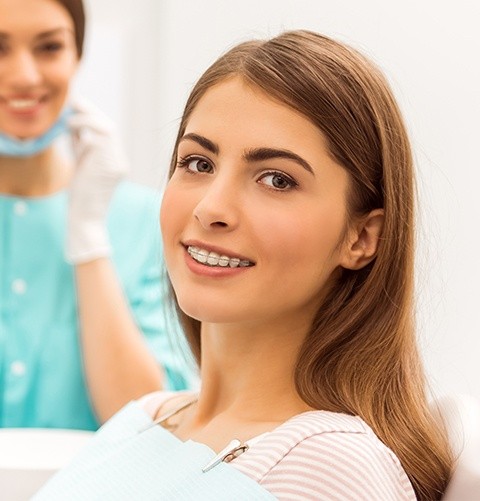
167 31 453 501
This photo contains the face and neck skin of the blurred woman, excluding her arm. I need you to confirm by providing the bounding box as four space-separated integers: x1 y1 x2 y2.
0 0 78 196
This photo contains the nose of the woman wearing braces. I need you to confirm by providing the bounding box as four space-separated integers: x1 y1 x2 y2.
193 170 241 231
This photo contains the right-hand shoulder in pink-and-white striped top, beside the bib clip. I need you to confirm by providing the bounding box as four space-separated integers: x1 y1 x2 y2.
235 411 415 501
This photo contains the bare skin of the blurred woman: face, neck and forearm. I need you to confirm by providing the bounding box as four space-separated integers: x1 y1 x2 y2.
0 0 163 422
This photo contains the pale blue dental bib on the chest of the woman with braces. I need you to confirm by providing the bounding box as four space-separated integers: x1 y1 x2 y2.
32 401 275 501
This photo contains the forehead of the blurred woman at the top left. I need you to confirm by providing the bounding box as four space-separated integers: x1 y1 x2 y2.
0 0 74 35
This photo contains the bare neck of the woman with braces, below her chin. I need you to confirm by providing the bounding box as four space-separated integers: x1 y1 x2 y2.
197 319 311 422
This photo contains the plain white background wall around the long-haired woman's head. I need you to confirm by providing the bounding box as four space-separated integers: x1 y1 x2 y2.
77 0 480 398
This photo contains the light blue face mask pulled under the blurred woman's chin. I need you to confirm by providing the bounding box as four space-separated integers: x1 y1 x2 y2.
0 108 72 157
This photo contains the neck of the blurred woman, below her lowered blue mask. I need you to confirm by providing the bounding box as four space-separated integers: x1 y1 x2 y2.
0 148 71 197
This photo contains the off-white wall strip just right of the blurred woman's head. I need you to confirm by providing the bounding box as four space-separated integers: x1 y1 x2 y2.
75 0 161 185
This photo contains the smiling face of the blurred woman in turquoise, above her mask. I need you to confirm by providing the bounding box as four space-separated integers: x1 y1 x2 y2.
0 0 78 139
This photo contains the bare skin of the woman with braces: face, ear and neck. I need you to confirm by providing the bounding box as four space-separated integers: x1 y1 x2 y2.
160 77 382 451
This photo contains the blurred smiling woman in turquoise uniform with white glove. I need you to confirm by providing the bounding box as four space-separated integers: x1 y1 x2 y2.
0 0 189 429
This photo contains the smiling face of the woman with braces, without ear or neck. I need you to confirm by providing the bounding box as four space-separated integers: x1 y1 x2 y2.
160 77 348 323
